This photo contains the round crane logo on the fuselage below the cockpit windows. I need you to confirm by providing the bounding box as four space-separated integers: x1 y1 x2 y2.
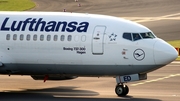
133 49 145 61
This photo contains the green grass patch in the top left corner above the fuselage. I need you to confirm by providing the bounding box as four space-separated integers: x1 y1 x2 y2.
0 0 35 11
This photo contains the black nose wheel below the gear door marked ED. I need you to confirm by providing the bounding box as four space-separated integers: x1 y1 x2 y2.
115 84 129 96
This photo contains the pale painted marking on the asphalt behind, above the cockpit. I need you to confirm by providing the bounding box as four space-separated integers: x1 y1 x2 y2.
122 13 180 22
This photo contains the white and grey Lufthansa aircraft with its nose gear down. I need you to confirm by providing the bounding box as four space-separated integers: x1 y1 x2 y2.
0 12 178 96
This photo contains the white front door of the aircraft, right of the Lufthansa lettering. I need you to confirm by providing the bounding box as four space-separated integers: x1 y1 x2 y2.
92 26 106 55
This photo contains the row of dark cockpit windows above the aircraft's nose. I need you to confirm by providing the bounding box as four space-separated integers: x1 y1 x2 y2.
123 32 156 41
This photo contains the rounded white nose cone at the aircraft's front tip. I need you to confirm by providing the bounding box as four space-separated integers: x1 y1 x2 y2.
154 39 178 65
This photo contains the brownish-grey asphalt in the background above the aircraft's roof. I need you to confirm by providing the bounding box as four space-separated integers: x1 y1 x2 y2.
32 0 180 41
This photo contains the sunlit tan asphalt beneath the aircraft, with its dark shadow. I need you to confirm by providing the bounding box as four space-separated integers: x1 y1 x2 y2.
0 62 180 101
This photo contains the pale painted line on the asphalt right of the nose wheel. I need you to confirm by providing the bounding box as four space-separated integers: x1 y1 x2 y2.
131 74 180 86
